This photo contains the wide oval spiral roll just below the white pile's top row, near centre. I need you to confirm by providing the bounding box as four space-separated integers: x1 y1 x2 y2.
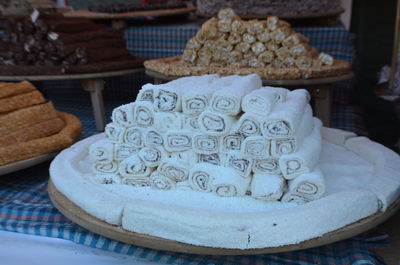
198 110 235 136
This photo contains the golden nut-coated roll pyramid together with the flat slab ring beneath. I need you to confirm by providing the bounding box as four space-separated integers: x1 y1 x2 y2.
145 9 350 79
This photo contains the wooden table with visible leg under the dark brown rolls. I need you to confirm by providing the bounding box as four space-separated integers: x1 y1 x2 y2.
0 68 143 131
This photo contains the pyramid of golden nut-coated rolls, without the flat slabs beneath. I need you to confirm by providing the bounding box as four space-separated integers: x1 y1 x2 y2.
182 9 333 68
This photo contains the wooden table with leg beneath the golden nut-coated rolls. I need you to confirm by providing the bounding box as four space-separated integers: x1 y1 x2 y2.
146 69 354 127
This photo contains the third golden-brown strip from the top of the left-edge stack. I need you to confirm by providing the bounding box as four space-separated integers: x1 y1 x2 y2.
0 102 57 135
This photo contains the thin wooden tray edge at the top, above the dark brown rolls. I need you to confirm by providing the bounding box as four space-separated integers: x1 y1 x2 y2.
63 6 196 19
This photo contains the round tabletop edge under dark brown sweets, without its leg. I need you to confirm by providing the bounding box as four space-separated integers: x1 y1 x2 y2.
0 68 143 81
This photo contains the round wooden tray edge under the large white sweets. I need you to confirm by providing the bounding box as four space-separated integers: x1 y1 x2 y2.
48 180 400 255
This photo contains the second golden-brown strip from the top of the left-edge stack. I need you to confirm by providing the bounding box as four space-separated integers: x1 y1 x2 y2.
0 90 46 114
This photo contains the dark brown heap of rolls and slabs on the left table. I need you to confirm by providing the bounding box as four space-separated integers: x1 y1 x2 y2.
0 14 142 75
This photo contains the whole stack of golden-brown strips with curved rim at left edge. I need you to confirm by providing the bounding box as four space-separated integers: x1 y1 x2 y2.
0 81 81 165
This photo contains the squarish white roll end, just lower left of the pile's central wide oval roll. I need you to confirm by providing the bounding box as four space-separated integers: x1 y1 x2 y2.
164 130 193 152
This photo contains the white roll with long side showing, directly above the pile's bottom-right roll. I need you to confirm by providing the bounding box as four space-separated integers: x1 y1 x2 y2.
279 119 322 179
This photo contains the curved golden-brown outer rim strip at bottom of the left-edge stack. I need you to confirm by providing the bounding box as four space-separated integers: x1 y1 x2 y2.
0 112 82 165
